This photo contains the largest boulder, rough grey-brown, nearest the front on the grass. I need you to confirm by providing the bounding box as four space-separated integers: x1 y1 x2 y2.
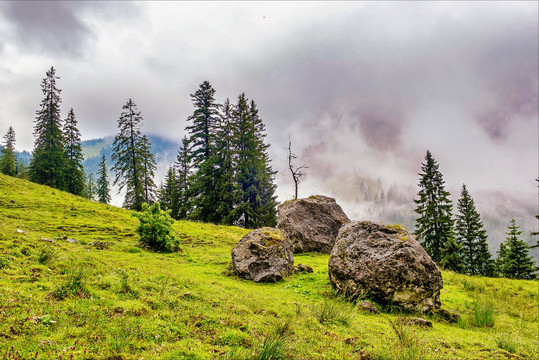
328 221 443 312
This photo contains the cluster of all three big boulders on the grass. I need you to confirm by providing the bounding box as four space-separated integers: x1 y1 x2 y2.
232 195 443 312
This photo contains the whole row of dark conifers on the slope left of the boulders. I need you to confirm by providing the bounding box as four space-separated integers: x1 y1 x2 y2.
0 67 277 228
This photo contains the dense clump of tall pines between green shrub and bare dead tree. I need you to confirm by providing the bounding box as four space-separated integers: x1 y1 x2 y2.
154 81 277 228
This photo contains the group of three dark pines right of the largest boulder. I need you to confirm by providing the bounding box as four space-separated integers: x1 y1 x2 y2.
414 151 537 279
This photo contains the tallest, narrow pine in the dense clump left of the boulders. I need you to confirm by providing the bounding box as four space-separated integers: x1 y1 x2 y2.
186 81 220 223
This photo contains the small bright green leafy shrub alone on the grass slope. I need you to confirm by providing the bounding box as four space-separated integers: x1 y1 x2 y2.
133 202 178 252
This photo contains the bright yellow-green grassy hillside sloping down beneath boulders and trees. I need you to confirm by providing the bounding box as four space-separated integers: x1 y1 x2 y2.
0 175 539 360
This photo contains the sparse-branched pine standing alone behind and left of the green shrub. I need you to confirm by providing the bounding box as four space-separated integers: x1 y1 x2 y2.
112 99 147 211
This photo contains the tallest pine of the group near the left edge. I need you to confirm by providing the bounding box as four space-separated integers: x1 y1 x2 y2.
29 67 66 190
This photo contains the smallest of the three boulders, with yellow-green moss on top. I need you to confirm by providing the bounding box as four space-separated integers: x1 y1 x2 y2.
232 227 294 282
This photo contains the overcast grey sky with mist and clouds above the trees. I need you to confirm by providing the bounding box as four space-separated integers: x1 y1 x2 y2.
0 1 539 228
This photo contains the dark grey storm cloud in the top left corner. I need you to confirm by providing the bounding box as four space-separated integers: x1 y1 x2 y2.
0 1 139 57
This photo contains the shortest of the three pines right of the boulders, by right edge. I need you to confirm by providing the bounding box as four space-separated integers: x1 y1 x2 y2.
497 219 536 279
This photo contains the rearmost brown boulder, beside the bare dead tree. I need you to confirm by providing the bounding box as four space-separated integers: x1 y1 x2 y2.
277 195 350 254
